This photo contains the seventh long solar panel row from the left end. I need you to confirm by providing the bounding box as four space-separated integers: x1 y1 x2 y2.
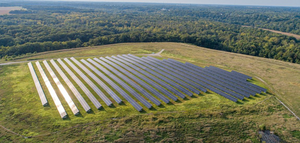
71 58 122 104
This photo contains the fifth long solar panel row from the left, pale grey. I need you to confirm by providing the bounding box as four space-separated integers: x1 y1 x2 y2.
57 59 102 109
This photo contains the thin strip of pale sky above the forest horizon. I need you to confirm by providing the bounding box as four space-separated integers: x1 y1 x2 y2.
47 0 300 7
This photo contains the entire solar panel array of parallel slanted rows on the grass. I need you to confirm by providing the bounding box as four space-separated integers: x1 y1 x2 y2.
28 54 267 118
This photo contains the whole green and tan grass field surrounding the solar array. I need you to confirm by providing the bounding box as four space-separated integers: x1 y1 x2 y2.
0 43 300 142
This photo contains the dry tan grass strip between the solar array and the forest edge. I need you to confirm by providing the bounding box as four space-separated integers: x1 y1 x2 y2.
3 42 300 115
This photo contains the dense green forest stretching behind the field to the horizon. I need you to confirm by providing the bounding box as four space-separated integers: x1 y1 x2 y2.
0 2 300 63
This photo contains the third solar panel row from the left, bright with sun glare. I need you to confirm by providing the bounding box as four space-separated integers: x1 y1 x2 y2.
43 60 79 115
